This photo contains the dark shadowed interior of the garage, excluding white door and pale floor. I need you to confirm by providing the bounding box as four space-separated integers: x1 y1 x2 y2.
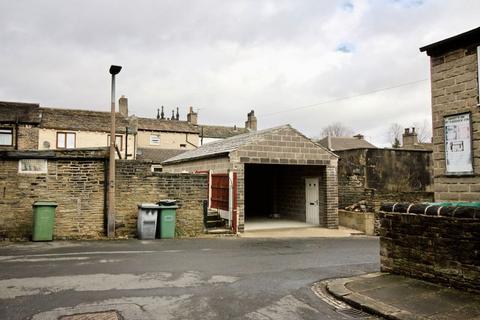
244 164 326 225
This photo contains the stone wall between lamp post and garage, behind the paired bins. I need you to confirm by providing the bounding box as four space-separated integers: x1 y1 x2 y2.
116 160 208 236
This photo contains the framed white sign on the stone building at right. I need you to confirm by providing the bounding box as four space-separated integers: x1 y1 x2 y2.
444 113 473 174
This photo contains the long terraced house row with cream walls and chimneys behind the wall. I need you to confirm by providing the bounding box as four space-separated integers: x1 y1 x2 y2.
0 96 256 162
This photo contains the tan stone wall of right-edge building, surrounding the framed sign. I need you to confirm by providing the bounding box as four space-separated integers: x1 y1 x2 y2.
430 45 480 201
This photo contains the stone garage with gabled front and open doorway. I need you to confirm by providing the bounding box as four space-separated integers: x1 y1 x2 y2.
163 125 338 232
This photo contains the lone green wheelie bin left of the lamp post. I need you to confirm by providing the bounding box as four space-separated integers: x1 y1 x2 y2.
32 201 57 241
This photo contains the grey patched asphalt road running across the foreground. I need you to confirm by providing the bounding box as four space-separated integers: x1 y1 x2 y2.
0 237 379 320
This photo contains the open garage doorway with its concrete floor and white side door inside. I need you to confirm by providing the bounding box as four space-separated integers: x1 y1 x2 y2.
244 164 327 231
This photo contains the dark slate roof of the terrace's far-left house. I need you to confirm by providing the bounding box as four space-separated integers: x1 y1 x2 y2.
0 101 40 124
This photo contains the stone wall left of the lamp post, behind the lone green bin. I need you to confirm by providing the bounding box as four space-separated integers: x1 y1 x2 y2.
0 150 106 239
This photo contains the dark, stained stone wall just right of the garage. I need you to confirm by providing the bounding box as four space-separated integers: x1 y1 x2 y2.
336 149 433 211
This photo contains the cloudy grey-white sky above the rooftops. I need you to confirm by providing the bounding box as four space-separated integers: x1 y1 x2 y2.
0 0 480 146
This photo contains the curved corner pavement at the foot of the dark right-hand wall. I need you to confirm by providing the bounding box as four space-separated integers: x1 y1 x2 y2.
326 272 480 320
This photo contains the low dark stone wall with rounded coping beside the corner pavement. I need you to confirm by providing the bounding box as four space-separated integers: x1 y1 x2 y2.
378 203 480 292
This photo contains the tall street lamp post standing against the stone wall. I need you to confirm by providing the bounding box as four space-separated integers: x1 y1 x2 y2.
107 65 122 238
